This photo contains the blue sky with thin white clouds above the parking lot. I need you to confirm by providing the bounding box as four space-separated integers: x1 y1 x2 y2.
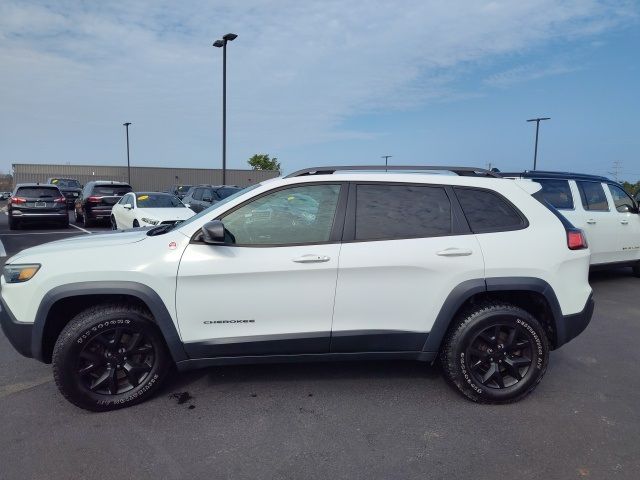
0 0 640 181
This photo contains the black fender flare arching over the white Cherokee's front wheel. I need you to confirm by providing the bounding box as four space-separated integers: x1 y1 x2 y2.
31 281 187 362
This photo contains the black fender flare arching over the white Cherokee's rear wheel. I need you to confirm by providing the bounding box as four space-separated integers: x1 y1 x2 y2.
422 277 566 354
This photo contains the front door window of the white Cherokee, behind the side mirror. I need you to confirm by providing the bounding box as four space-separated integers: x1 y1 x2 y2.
222 184 340 245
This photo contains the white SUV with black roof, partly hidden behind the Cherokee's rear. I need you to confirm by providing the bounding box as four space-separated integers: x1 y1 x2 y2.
501 170 640 276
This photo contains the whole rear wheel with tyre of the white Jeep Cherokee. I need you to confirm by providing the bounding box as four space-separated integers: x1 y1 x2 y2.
440 303 550 403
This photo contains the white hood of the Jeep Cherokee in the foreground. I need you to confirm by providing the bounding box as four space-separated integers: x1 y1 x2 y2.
6 229 148 263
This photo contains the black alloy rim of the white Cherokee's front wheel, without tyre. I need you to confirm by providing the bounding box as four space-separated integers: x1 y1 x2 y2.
76 326 156 395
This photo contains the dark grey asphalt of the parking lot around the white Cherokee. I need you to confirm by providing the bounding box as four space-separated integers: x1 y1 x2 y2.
0 209 640 480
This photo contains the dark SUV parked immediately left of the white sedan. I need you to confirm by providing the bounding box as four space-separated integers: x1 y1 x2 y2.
73 180 133 227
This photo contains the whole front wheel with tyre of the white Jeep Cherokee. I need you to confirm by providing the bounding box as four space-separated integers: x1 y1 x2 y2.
52 304 170 411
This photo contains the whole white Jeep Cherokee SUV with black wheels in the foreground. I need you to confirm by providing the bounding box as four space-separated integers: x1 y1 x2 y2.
1 166 593 410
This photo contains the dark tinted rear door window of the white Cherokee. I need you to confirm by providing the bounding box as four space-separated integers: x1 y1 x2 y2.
356 184 451 240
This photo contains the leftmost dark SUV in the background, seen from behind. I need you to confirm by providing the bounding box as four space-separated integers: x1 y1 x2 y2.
7 183 69 230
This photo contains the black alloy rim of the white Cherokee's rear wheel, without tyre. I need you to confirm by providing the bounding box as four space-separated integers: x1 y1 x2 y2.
466 324 535 389
